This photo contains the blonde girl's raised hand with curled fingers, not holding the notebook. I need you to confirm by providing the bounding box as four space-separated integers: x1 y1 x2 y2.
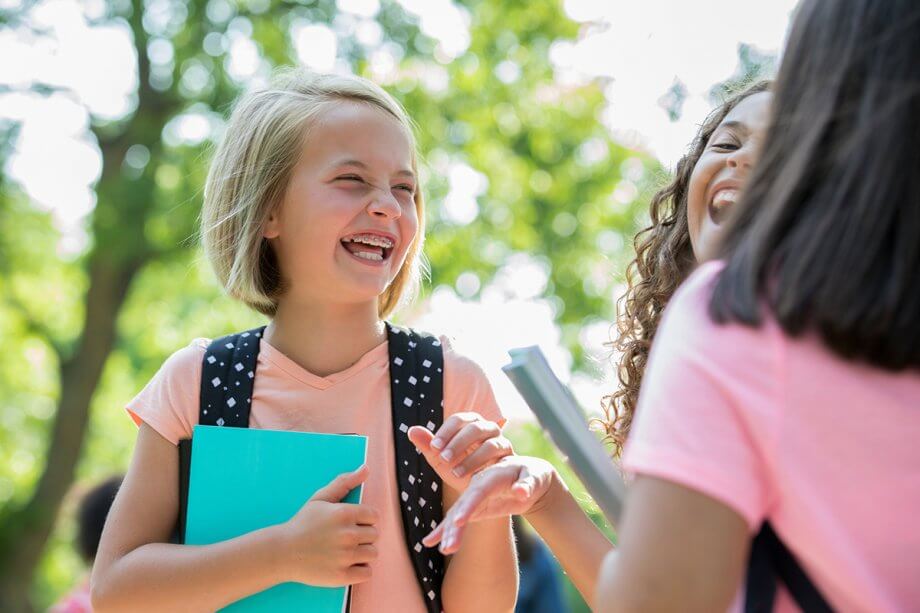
408 413 514 492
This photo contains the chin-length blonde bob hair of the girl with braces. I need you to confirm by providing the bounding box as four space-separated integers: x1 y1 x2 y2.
201 69 425 318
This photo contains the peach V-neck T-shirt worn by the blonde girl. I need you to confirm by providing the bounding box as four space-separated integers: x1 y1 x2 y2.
128 338 504 613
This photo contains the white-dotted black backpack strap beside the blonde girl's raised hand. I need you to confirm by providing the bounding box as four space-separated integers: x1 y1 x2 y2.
387 323 444 613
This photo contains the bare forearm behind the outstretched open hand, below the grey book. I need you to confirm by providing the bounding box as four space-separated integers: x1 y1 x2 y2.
525 474 613 605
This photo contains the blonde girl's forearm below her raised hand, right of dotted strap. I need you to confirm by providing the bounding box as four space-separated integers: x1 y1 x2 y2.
441 492 518 613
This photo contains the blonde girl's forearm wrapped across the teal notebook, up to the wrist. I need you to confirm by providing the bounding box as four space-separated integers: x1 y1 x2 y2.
92 526 287 613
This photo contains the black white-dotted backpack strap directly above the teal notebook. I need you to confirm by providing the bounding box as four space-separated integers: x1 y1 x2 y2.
198 326 265 428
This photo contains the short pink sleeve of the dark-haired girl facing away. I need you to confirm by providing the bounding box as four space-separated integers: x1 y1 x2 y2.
623 263 781 530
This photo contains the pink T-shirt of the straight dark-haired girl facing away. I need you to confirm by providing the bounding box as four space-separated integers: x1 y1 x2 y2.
624 263 920 611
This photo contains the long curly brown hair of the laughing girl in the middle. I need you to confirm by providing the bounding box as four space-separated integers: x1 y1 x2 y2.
599 81 771 457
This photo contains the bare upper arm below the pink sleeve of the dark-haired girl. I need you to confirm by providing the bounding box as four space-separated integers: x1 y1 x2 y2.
595 475 750 613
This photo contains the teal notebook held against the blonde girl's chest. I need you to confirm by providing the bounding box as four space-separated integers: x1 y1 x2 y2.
185 426 367 613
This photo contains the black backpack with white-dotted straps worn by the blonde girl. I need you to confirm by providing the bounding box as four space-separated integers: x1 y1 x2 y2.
177 322 444 613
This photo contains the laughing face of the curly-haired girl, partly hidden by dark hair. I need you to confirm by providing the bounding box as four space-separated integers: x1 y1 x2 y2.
687 92 773 260
